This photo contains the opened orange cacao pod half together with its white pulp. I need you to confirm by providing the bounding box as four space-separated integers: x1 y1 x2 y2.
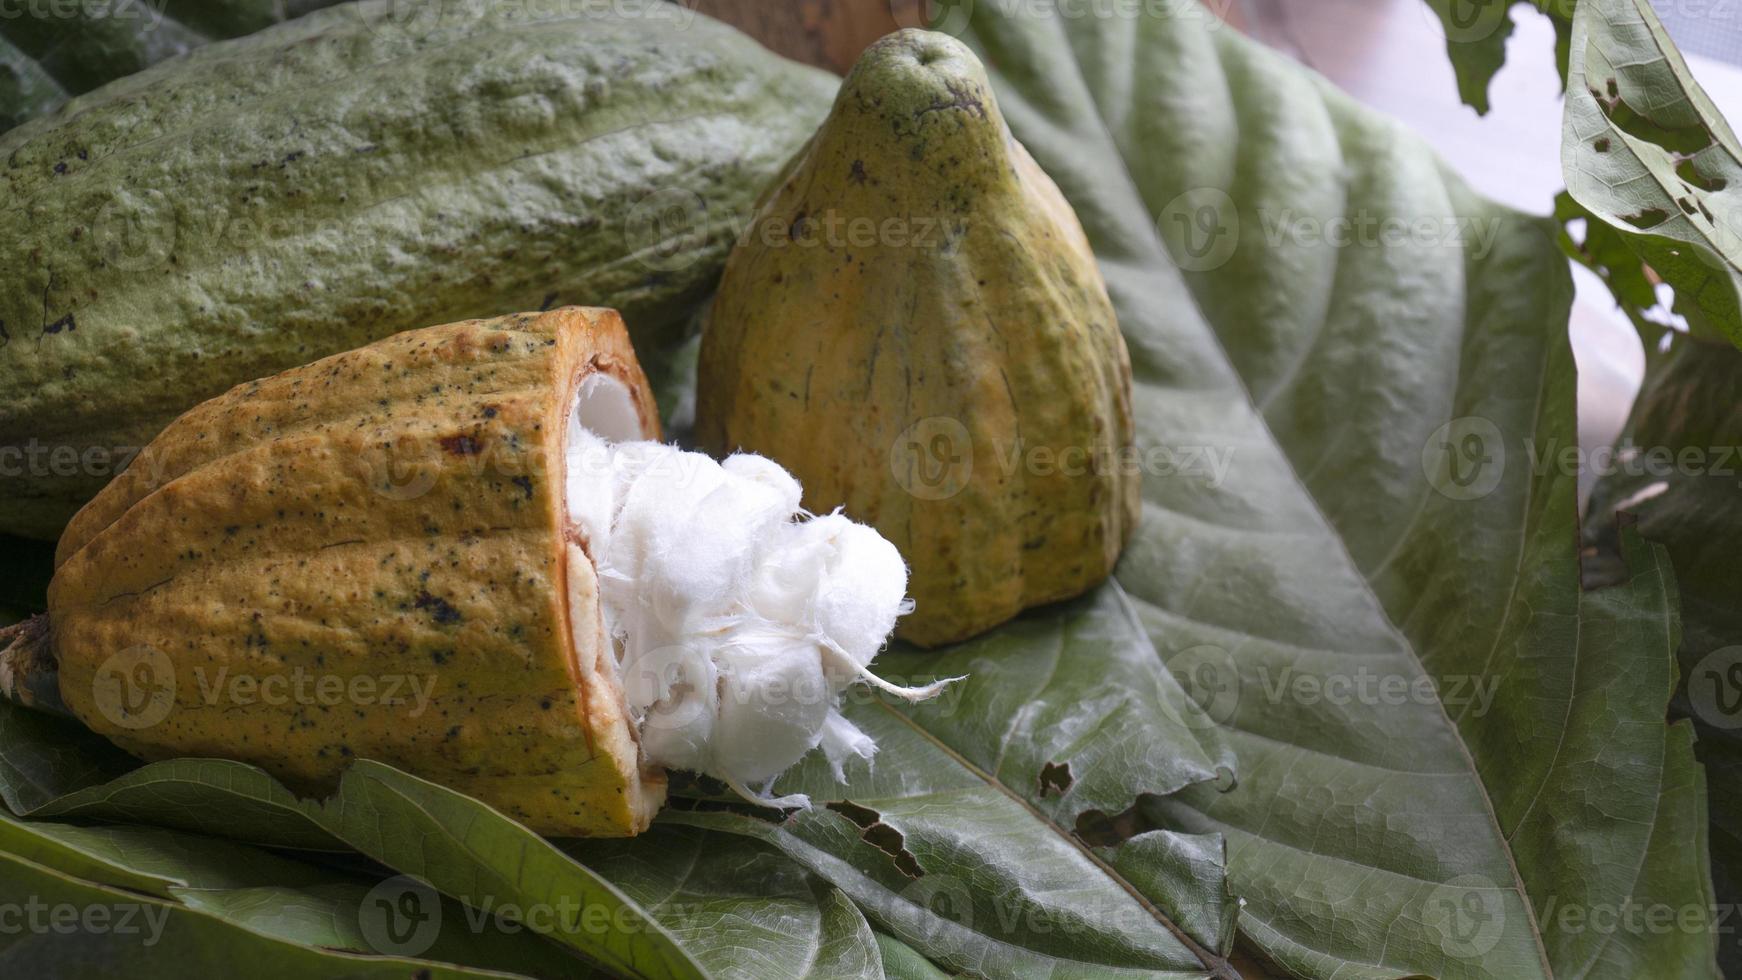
13 308 939 836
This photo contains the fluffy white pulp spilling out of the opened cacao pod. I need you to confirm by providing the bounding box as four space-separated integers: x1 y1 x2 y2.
566 373 942 806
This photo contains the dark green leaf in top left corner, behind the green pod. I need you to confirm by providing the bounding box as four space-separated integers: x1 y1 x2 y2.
0 0 336 132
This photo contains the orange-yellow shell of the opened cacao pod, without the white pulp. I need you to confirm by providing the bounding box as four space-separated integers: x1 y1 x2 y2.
49 308 665 836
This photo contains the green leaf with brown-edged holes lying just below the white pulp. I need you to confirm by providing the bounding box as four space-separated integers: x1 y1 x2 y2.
664 585 1232 977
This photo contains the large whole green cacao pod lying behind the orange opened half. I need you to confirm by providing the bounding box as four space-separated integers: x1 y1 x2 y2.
0 0 836 538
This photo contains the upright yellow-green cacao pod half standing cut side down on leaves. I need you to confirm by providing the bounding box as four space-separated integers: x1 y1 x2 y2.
697 31 1139 646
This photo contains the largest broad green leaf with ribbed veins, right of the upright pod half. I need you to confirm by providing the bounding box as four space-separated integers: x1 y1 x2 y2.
946 3 1712 977
